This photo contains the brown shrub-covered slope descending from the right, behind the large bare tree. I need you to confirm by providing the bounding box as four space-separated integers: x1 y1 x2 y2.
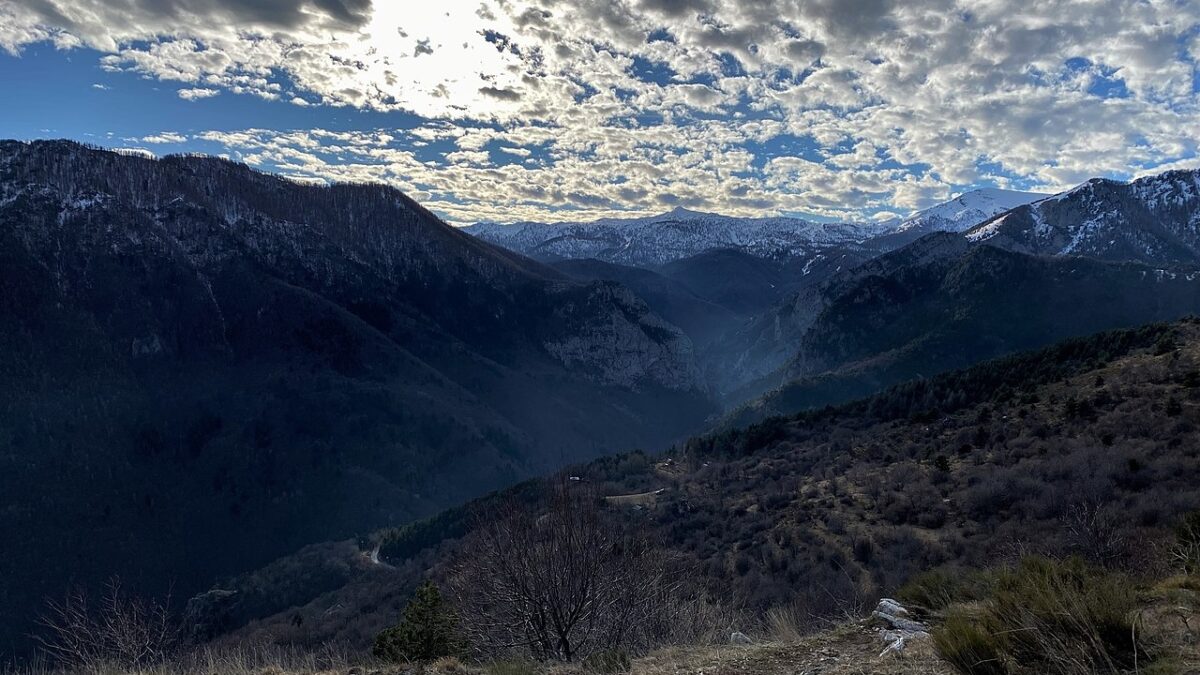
196 321 1200 644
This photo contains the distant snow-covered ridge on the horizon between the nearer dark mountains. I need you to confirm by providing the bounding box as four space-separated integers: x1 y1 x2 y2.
464 208 887 265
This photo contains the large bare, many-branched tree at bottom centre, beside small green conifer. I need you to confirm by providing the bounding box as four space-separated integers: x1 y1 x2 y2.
450 484 680 661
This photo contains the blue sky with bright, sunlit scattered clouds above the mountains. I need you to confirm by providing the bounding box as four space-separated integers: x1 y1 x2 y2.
0 0 1200 223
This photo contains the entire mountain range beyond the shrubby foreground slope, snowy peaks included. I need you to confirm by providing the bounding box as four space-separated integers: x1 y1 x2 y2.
0 136 1200 649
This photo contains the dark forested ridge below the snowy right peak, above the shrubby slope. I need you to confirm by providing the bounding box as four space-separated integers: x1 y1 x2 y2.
708 233 1200 417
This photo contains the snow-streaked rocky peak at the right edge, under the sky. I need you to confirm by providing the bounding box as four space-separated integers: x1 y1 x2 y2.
966 171 1200 265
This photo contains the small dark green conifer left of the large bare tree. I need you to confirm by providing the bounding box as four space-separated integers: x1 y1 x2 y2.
371 581 463 662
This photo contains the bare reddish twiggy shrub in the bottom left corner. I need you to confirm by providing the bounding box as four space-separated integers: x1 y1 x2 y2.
36 578 179 671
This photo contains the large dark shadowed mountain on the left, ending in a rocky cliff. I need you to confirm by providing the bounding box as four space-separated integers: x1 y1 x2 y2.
0 142 709 649
